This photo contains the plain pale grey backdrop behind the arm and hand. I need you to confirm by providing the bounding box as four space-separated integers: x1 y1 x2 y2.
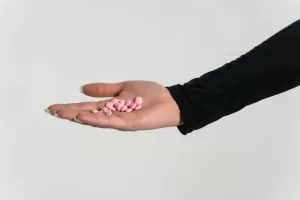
0 0 300 200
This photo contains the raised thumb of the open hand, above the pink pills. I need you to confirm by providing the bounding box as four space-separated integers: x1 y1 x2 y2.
80 83 124 97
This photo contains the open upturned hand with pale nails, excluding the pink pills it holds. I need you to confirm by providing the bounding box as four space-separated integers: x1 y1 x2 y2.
46 81 181 131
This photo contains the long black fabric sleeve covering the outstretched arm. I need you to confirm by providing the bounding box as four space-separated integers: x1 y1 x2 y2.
167 20 300 135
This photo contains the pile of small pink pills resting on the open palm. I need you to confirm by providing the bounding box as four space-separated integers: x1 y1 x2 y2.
92 97 143 115
